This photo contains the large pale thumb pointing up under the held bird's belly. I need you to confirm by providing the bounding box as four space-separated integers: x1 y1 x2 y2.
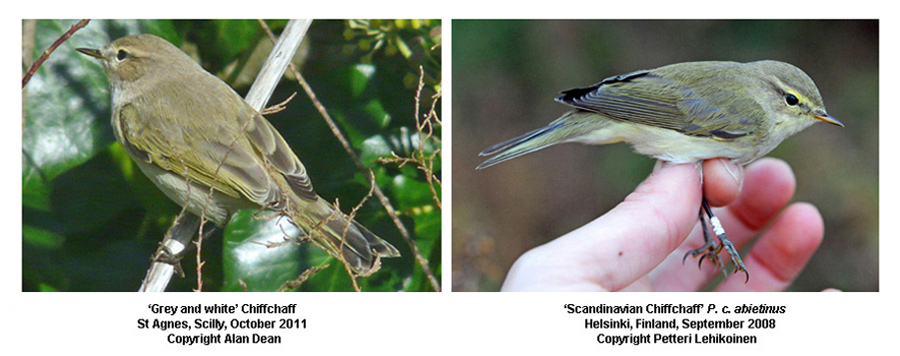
503 164 700 290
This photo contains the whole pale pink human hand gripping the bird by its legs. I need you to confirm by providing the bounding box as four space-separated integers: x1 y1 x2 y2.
502 158 824 291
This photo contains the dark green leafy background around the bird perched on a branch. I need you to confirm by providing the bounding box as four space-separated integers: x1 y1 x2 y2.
22 20 441 291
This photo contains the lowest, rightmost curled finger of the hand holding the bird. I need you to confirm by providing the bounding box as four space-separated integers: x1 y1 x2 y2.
716 203 825 292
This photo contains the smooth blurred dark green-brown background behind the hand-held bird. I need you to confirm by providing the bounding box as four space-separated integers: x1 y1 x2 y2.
452 20 879 291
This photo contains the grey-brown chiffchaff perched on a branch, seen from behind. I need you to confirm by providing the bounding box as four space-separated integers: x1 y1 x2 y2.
77 35 400 275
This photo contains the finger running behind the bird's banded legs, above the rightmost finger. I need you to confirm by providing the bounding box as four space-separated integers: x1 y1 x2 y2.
651 158 796 290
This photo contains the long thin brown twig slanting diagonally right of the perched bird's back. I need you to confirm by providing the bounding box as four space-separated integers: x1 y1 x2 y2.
262 23 441 291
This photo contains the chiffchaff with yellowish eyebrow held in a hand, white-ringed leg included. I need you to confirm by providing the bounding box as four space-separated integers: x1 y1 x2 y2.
477 61 843 279
